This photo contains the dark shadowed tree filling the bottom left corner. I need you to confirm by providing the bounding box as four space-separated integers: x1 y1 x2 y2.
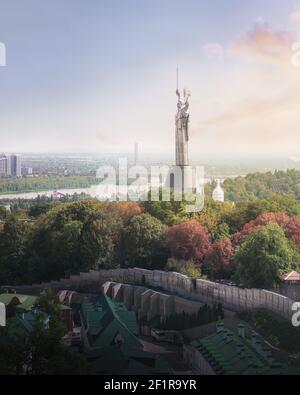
0 292 91 375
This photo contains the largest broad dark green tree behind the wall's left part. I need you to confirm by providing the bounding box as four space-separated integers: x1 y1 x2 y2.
26 200 123 281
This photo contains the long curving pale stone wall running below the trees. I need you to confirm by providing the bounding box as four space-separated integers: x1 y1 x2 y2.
7 268 294 319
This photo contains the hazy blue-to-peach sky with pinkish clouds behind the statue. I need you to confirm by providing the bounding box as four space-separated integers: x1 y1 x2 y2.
0 0 300 161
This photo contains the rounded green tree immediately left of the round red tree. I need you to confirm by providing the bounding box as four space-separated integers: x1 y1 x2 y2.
122 214 167 269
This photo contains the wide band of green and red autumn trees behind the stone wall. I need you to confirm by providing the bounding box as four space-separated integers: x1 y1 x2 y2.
0 171 300 289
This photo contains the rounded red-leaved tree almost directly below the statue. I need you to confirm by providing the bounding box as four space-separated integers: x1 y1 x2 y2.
166 220 211 265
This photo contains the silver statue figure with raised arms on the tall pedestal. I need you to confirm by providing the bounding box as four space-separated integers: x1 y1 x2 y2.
175 89 191 166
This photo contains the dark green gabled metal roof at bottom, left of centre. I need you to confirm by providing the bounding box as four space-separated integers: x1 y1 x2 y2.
81 294 169 375
